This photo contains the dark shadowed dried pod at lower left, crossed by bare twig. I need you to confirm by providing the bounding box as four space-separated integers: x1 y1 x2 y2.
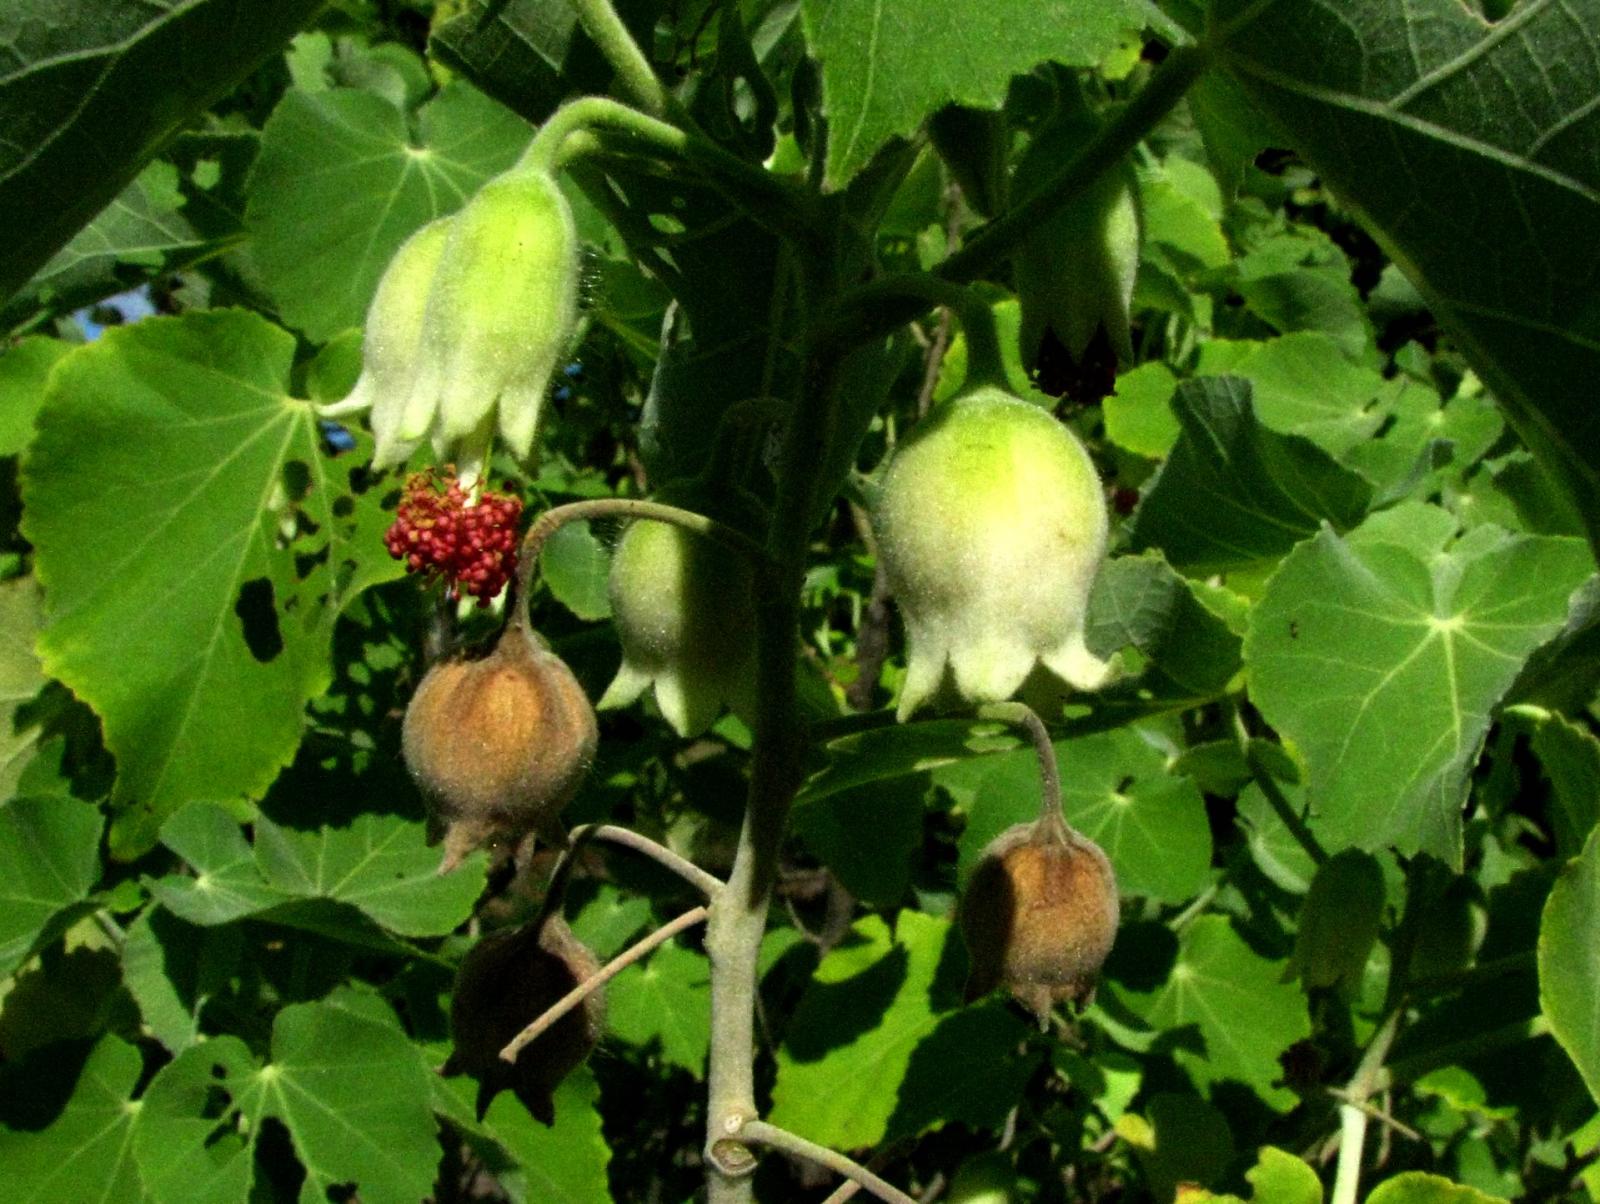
445 914 605 1124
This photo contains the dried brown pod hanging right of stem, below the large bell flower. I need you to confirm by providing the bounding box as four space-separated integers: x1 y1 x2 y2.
960 815 1117 1023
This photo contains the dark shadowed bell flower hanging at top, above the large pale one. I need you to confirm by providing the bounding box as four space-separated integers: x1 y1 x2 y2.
1013 122 1141 377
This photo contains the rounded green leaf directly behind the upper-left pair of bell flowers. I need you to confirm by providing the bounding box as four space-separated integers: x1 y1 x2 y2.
245 83 531 343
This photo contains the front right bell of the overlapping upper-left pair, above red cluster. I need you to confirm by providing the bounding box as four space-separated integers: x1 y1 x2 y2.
398 171 578 477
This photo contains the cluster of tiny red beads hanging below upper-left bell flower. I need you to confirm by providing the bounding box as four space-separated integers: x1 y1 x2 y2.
384 471 522 607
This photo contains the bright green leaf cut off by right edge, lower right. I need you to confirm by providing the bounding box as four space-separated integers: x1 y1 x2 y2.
1539 829 1600 1100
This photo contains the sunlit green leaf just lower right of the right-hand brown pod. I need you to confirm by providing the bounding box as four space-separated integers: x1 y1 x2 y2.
1130 916 1310 1111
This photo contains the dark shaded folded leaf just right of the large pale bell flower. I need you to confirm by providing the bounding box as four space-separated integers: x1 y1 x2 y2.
1131 376 1371 575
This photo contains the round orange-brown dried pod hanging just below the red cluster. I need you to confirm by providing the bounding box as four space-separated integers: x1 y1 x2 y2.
402 624 597 869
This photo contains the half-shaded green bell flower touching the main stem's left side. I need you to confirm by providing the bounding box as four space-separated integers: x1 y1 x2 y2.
600 520 755 735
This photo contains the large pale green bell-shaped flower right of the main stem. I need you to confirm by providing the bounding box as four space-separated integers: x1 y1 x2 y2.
874 387 1110 720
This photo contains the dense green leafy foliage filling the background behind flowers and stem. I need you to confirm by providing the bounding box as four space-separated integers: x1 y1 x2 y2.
0 0 1600 1204
